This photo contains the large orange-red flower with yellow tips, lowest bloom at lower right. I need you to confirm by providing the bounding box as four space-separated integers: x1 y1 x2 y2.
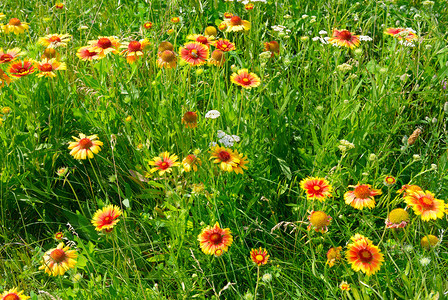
345 238 384 276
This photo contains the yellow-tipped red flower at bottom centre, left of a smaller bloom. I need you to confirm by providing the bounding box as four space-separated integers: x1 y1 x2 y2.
198 222 233 256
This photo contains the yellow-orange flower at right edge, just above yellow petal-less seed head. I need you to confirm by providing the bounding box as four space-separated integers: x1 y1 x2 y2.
404 191 445 221
